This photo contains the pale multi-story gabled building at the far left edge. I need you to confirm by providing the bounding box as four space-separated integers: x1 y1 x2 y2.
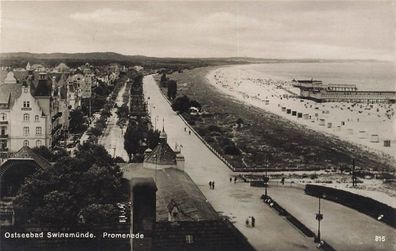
0 72 51 153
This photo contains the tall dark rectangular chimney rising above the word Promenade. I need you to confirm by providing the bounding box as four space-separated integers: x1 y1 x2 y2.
131 177 157 251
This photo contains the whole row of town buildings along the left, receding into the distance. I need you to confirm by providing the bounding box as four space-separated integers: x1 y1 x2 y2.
0 63 117 159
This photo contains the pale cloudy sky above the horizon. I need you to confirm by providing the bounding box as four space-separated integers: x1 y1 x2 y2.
0 0 396 61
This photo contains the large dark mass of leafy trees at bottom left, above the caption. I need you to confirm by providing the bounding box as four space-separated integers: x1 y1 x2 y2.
14 143 129 227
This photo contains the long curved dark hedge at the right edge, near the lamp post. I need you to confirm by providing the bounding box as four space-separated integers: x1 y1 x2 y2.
305 184 396 228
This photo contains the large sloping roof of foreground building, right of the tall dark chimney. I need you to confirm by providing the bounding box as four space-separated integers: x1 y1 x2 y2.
128 164 219 221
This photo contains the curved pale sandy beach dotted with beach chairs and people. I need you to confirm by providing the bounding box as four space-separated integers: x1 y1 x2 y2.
206 65 396 165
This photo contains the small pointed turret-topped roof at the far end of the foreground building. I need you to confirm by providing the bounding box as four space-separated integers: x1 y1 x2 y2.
144 141 176 165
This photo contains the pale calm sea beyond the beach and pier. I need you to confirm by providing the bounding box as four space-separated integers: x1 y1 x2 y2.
241 61 396 91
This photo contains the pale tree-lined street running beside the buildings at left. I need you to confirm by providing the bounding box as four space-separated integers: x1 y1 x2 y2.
99 83 129 161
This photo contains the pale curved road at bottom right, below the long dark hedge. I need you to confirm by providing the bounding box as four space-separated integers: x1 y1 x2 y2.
269 183 396 251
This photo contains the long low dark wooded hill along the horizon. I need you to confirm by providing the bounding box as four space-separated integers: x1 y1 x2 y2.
0 52 384 68
